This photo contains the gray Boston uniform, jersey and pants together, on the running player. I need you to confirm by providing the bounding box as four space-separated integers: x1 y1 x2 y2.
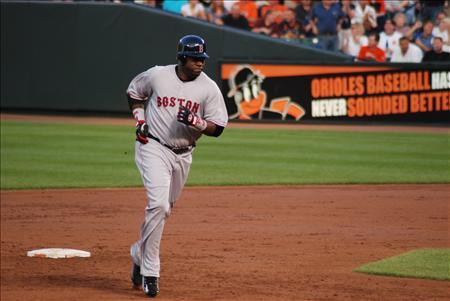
127 65 228 277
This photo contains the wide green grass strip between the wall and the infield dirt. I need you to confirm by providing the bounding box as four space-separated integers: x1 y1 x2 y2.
1 121 450 189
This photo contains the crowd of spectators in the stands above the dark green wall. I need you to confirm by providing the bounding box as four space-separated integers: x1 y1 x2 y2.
129 0 450 62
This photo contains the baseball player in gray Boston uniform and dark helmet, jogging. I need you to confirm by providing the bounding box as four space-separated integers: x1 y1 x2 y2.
127 35 228 297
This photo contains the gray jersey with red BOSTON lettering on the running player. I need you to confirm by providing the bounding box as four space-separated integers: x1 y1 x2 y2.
127 65 228 147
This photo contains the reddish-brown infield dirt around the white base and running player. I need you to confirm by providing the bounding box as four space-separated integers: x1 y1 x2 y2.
1 185 450 301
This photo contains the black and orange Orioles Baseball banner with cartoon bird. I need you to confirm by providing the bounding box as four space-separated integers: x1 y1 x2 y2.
221 64 450 123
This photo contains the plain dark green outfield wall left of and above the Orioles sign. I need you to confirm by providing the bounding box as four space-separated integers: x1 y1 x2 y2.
1 2 348 112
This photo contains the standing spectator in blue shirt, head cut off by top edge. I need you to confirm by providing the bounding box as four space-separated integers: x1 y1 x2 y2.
311 0 344 51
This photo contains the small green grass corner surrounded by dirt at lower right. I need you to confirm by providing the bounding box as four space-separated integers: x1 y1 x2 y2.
354 249 450 280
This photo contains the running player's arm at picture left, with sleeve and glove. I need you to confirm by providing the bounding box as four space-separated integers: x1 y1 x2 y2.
127 69 152 144
